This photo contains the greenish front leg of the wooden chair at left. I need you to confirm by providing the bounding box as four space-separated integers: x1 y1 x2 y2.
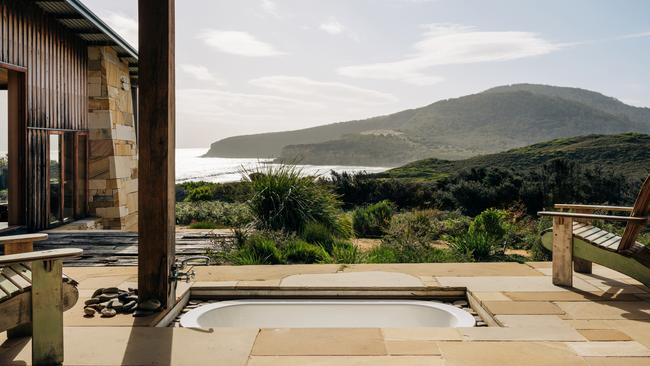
32 259 63 365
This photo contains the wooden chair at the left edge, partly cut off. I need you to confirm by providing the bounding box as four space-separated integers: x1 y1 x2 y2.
0 235 82 365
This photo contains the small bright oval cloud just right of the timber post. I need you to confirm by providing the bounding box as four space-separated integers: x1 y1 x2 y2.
198 29 284 57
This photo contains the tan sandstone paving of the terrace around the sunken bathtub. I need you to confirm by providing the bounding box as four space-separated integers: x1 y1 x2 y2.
0 263 650 366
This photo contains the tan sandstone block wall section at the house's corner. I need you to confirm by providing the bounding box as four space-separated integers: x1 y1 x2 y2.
88 47 138 231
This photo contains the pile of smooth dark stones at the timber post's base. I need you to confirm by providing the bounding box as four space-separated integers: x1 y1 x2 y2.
84 287 160 318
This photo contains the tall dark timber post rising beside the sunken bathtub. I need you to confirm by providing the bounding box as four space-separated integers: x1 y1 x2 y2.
138 0 176 307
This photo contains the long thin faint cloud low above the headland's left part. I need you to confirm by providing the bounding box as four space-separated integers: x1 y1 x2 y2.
249 75 398 105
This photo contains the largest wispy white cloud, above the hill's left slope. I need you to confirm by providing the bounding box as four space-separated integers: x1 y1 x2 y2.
338 24 562 85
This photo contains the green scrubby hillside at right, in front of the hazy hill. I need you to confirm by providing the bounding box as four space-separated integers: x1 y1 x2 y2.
379 133 650 180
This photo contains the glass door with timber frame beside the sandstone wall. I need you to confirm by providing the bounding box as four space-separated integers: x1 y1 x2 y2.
48 131 88 226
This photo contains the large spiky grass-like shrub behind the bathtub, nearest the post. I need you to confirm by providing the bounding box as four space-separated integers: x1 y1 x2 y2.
248 165 346 235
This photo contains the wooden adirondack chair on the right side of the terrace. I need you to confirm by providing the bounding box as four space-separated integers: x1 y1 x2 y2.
539 176 650 287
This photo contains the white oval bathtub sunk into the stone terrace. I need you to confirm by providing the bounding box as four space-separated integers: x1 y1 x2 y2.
181 300 474 328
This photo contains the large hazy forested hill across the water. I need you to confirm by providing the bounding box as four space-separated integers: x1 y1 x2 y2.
206 84 650 166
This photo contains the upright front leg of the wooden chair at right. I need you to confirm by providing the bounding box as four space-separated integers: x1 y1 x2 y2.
553 217 573 287
